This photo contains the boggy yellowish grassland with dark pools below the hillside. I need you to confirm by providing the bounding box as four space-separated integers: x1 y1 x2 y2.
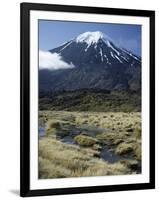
39 111 141 179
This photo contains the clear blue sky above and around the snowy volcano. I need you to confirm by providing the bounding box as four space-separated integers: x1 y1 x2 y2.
39 20 141 56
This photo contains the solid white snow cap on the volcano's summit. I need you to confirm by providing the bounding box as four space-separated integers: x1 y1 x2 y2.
76 31 104 45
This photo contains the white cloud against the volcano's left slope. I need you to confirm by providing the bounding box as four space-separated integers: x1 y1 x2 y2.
39 50 75 70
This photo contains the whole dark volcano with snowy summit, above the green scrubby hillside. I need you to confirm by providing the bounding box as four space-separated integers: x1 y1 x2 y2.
39 31 141 91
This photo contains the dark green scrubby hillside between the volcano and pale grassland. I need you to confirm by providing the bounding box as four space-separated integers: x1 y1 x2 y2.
39 89 141 112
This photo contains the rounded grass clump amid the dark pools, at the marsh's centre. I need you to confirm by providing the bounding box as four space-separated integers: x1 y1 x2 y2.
74 135 97 147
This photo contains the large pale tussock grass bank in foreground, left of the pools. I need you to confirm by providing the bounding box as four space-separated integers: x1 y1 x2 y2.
39 138 131 179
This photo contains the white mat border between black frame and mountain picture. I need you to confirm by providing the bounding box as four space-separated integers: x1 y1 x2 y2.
30 11 150 190
